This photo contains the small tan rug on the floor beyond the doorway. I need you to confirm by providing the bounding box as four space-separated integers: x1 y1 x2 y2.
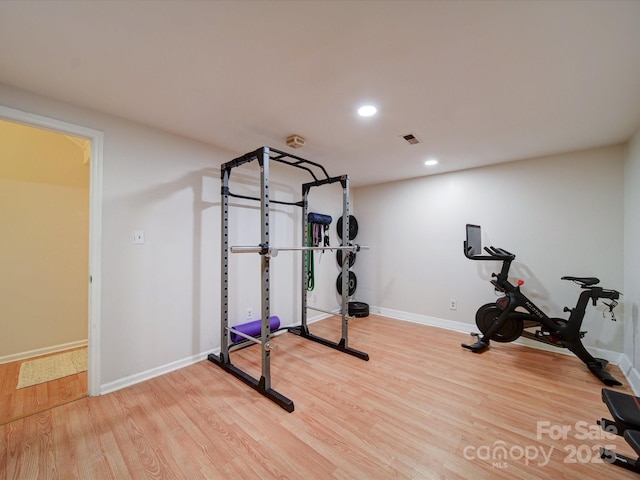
16 348 87 389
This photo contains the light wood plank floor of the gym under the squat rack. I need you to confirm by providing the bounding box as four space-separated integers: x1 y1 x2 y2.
0 316 638 480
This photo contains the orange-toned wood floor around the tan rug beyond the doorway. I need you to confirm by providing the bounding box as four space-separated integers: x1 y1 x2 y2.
0 347 87 424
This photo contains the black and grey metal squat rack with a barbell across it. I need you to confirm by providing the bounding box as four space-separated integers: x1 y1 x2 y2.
208 147 369 412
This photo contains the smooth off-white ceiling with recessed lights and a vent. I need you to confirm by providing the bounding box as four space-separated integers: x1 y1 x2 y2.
0 0 640 186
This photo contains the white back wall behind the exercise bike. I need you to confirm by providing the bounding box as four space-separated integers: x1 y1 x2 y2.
354 146 625 352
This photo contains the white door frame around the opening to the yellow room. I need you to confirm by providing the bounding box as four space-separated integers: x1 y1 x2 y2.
0 105 104 396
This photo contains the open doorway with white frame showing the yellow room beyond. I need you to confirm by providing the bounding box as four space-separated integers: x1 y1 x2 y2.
0 106 102 423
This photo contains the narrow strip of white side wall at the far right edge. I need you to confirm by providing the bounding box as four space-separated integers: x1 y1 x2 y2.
623 131 640 392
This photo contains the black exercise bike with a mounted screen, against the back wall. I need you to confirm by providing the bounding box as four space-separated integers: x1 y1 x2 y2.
462 225 622 386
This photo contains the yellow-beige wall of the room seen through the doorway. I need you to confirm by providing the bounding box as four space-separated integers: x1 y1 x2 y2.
0 121 89 361
